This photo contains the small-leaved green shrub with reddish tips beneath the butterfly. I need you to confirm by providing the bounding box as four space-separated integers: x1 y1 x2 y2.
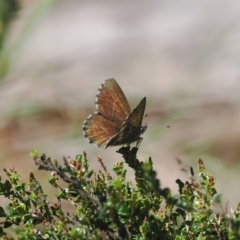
0 147 240 240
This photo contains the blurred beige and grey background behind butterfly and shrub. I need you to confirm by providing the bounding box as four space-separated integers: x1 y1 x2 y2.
0 0 240 208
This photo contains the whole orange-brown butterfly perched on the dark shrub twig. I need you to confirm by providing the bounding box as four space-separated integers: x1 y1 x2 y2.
83 78 147 148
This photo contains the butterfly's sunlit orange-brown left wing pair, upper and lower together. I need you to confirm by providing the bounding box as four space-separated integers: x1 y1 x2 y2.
83 78 131 147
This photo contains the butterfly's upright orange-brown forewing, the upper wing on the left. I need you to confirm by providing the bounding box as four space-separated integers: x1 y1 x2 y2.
97 78 131 124
